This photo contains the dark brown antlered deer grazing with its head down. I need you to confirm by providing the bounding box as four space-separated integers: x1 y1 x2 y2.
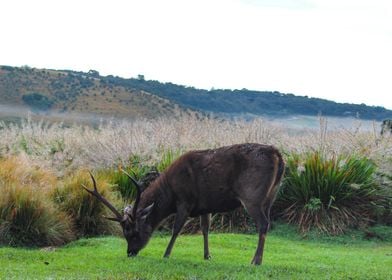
83 143 285 265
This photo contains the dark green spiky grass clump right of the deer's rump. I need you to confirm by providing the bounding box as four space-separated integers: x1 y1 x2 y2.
275 152 383 234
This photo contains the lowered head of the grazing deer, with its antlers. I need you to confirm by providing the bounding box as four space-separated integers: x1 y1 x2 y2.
82 170 154 257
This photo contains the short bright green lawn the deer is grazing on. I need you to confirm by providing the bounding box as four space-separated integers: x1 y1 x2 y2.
0 225 392 279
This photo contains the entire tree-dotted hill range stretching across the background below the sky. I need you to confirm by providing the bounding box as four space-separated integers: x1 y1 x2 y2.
0 66 392 120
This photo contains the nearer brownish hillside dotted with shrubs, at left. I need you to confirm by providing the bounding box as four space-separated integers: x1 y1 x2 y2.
0 66 196 118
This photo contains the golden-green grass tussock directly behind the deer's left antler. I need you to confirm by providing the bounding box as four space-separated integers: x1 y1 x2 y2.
51 172 121 237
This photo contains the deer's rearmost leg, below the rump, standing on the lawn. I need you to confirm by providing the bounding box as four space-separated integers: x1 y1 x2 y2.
246 205 270 265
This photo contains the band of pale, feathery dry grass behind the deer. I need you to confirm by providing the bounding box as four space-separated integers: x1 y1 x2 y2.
0 115 392 176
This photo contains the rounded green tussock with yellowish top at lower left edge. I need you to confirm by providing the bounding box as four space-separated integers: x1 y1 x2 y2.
0 183 74 246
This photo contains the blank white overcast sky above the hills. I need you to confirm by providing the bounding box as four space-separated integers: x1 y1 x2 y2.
0 0 392 109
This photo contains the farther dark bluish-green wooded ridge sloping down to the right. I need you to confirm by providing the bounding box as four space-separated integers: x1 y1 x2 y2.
105 76 392 120
